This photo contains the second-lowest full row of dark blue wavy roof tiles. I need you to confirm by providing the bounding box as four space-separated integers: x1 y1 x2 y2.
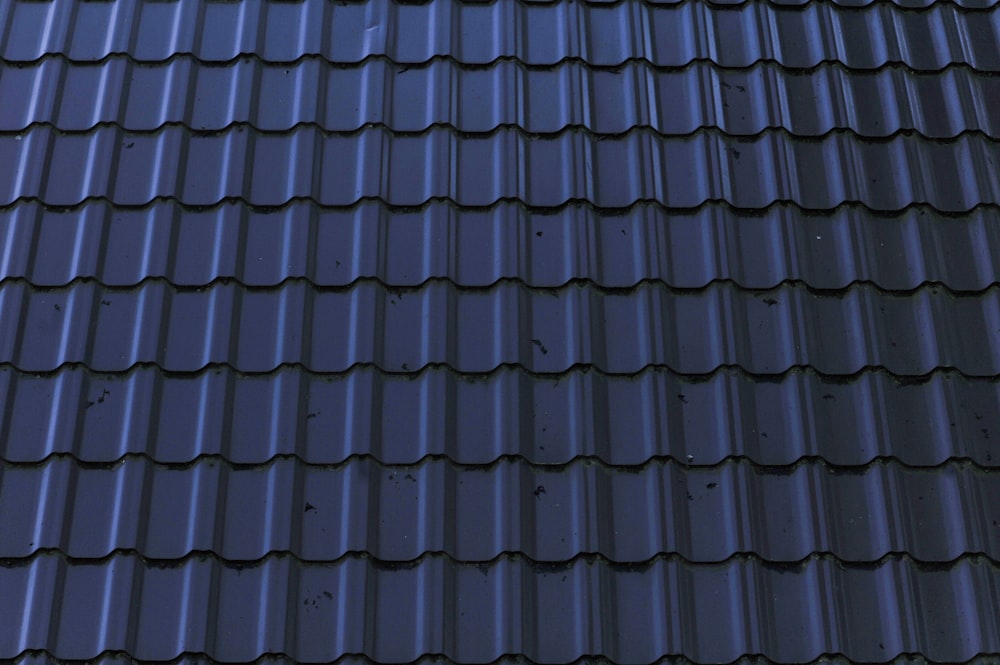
0 458 1000 565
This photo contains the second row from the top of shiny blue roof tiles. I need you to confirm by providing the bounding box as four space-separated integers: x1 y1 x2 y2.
0 56 1000 139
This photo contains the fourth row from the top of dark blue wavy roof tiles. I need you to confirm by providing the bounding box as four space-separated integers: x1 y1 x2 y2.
0 201 1000 291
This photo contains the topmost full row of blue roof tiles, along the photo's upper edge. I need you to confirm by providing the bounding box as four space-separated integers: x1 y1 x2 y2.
0 0 1000 71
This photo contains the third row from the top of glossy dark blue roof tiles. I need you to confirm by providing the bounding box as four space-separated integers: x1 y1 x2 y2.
0 125 1000 212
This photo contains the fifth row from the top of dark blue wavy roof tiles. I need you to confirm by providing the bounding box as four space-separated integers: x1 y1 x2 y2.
0 281 1000 377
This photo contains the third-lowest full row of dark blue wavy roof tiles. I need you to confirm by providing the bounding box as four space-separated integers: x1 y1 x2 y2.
0 366 1000 470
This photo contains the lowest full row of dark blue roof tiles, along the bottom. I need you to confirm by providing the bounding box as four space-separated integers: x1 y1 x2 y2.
0 555 1000 663
